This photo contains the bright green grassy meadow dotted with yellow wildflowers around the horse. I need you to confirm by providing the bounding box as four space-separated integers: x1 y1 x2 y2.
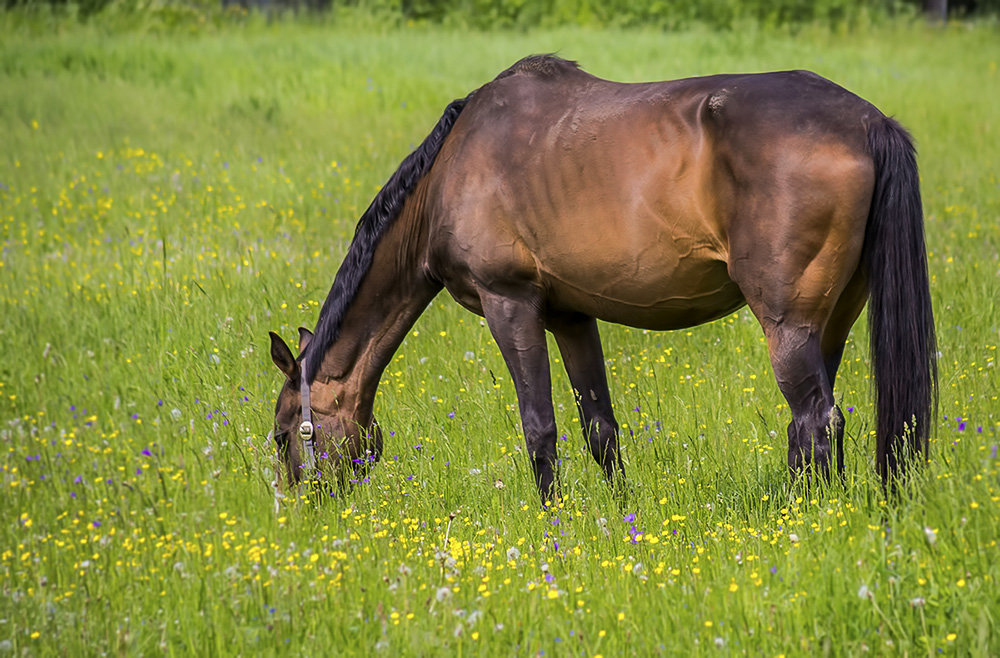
0 14 1000 656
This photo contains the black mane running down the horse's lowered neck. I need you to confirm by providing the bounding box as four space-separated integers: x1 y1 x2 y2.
302 92 475 383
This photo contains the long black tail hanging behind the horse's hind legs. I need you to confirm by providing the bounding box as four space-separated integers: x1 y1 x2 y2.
864 118 937 485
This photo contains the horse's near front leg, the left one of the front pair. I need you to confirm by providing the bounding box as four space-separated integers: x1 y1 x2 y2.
481 293 556 503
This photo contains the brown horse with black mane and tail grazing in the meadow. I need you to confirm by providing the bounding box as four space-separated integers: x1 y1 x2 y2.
271 56 937 500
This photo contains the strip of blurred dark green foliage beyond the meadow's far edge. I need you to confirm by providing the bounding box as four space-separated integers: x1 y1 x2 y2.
4 0 1000 30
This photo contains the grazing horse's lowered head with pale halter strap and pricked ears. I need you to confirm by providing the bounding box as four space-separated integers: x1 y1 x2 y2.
270 327 382 485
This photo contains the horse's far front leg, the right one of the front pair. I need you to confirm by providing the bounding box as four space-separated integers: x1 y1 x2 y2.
546 314 625 485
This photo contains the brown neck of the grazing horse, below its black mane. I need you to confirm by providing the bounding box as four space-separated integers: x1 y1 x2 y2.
315 204 441 415
